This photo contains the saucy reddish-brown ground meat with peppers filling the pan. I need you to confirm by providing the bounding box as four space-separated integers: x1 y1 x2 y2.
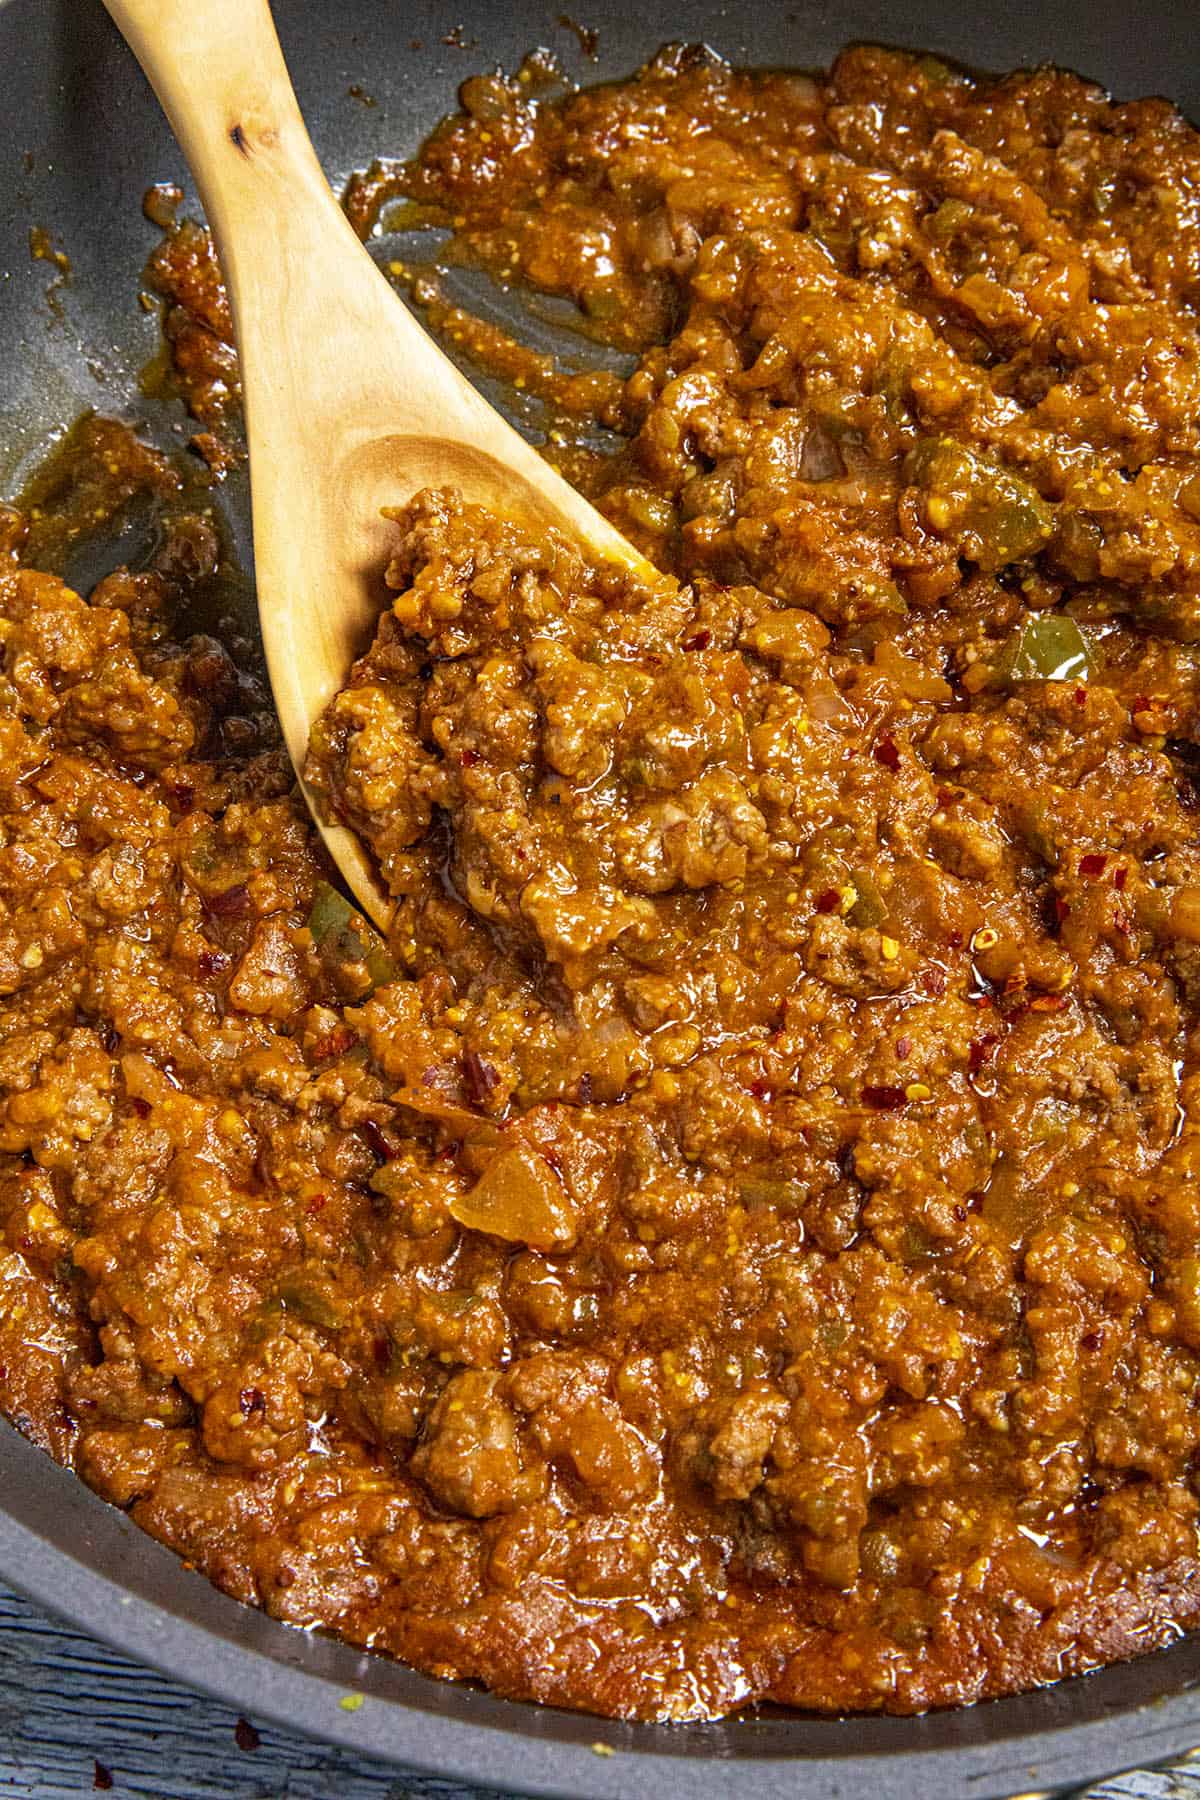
0 50 1200 1719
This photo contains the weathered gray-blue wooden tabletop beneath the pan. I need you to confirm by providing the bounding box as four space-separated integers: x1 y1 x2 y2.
0 1588 1200 1800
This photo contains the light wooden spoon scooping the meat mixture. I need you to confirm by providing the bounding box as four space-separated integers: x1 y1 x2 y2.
106 0 653 927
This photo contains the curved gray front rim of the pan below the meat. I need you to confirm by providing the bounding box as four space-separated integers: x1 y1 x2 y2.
0 1422 1200 1800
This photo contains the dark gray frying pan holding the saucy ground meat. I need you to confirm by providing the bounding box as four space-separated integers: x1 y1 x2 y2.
0 0 1200 1800
